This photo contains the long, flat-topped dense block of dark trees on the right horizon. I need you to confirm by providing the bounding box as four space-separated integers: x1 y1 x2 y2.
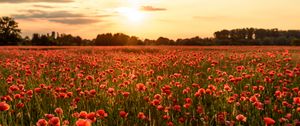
214 28 300 45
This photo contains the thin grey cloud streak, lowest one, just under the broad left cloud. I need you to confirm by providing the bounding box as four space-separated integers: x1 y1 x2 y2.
48 18 100 25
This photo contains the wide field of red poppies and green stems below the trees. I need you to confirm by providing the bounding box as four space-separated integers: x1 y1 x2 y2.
0 46 300 126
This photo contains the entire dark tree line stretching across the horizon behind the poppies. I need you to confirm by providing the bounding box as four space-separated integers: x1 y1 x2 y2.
0 17 300 46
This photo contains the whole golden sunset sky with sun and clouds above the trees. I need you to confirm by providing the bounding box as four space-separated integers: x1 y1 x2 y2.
0 0 300 39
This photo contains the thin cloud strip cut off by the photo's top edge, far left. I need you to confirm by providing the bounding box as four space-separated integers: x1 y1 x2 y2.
0 0 73 3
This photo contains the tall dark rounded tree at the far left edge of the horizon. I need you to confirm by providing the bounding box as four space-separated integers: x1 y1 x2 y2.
0 17 21 45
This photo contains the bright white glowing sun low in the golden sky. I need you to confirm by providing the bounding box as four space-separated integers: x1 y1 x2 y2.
117 7 145 23
